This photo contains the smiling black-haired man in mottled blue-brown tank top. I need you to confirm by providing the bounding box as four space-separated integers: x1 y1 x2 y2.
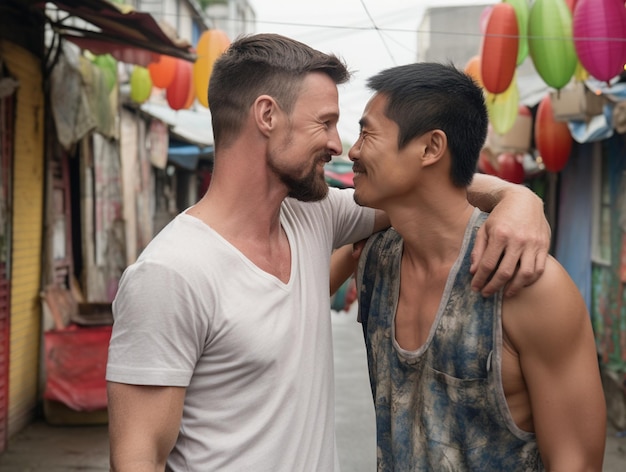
349 63 606 472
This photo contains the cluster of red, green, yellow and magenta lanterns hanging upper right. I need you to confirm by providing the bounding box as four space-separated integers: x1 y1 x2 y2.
465 0 626 183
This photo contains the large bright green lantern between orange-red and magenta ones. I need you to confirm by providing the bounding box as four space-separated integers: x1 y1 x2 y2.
528 0 578 89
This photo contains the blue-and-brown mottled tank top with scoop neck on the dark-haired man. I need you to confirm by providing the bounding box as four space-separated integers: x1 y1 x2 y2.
357 210 545 472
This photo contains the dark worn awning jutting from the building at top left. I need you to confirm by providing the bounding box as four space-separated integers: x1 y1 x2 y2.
31 0 196 67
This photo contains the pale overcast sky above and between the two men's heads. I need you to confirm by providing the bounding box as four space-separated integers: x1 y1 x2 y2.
250 0 497 148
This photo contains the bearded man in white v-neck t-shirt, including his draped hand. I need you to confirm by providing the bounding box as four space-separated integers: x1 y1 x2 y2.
107 34 549 472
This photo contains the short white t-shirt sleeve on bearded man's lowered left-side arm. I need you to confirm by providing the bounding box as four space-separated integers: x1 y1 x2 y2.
106 262 208 387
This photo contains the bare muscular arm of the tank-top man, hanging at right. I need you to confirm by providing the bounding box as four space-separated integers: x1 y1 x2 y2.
503 258 606 472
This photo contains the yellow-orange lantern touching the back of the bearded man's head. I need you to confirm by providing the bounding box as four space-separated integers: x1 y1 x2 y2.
193 29 230 107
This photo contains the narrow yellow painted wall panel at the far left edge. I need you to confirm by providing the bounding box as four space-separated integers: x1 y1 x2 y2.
0 40 45 437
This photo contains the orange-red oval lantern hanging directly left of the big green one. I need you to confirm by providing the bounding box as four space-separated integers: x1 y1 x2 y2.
480 3 519 93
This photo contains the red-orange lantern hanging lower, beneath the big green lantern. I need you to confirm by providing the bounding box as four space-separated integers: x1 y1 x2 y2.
535 94 573 172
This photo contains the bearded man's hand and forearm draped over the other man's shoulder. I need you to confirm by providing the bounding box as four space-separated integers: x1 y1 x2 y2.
467 174 551 296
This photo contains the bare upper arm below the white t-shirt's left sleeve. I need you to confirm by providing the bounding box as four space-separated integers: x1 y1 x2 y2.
107 382 185 472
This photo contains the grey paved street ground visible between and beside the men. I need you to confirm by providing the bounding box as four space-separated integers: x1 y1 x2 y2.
0 312 626 472
